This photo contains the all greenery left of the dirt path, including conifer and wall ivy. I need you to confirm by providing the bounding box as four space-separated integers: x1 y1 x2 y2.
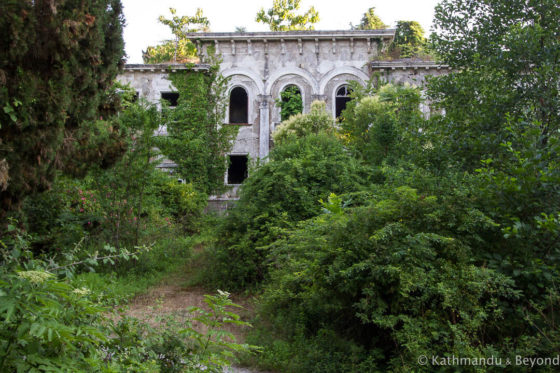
0 1 249 372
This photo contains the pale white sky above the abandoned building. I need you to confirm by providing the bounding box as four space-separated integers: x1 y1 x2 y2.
122 0 438 63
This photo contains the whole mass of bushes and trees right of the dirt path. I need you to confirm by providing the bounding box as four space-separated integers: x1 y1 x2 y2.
205 0 560 372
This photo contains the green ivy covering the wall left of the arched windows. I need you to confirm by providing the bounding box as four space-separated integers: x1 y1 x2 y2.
159 63 238 194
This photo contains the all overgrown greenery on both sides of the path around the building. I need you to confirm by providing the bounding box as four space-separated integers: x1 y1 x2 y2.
0 0 560 372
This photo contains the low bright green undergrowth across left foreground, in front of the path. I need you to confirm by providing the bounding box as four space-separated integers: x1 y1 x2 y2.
0 222 252 372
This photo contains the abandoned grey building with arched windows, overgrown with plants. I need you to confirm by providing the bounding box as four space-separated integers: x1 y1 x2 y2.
119 29 448 204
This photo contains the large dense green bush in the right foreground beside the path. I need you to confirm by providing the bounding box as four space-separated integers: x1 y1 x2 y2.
261 169 520 371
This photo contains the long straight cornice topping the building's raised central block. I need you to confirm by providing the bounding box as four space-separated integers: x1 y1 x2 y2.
186 29 395 41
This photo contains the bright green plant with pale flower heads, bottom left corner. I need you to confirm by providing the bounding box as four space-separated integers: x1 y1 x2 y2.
0 270 105 372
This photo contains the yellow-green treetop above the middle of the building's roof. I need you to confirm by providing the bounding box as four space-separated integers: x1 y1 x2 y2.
256 0 319 31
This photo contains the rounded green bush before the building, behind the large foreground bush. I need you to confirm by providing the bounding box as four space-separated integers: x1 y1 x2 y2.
209 133 367 288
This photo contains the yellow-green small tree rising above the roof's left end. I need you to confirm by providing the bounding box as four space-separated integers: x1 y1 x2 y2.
143 8 210 63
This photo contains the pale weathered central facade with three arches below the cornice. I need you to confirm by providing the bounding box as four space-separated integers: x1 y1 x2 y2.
189 30 394 159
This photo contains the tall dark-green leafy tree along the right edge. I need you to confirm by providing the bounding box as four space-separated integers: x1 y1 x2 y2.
424 0 560 306
